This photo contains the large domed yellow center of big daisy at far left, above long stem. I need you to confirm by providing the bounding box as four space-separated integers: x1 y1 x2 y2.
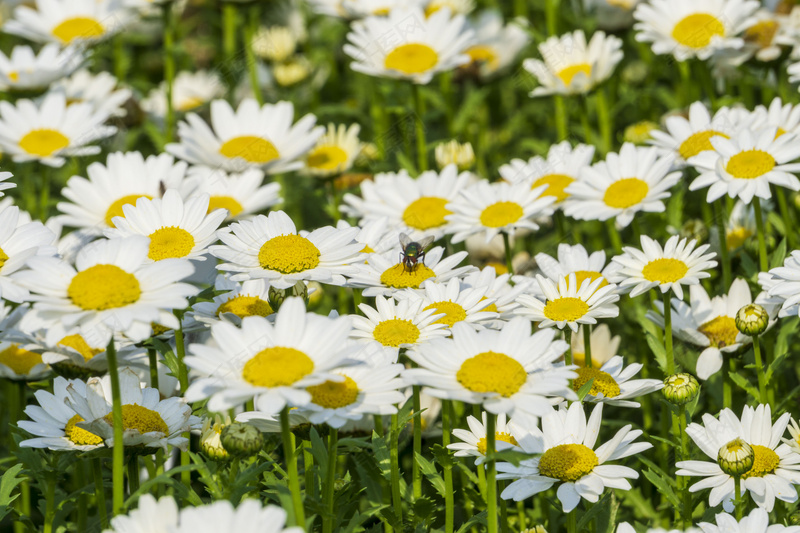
67 265 142 311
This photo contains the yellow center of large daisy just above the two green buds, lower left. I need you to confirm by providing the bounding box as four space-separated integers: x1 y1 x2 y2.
242 346 314 388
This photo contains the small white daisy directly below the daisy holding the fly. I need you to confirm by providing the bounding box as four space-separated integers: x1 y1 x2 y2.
350 296 450 352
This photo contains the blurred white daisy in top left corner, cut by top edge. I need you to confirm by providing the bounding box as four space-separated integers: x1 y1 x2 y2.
3 0 133 46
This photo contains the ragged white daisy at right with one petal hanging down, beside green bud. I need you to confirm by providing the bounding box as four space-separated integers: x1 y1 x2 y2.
647 278 775 379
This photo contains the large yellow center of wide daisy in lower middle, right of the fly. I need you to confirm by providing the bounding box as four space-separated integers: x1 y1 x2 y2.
456 352 528 398
